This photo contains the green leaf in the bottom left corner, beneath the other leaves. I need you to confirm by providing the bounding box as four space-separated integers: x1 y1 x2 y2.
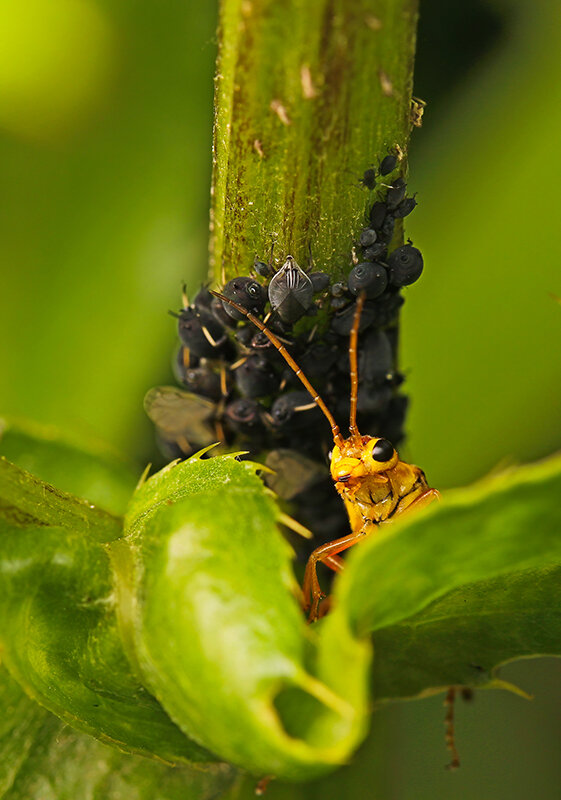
0 668 234 800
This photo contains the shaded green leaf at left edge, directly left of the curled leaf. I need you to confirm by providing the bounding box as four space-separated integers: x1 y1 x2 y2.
0 459 215 761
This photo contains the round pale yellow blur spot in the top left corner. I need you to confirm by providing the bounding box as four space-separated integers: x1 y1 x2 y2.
0 0 115 141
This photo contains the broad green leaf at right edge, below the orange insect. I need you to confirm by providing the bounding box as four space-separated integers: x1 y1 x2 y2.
323 456 561 700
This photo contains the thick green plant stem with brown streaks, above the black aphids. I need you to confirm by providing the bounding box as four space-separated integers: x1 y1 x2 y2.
211 0 417 281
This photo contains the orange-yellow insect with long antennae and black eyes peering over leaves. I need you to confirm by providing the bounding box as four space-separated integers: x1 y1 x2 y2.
212 292 439 622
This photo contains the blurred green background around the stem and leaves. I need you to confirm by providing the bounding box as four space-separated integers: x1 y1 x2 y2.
0 0 561 800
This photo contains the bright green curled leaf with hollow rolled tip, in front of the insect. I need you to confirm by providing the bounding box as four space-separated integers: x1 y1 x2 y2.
111 456 368 780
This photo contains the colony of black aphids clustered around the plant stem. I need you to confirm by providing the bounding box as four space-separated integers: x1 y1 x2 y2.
145 155 423 545
